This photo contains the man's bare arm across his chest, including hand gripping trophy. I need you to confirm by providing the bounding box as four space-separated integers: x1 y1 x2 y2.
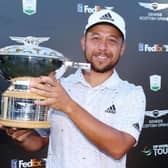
31 77 136 159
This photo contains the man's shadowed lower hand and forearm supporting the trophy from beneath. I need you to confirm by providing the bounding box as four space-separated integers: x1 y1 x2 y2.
0 126 48 152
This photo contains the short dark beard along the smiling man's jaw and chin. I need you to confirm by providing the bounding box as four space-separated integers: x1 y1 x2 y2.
85 53 120 73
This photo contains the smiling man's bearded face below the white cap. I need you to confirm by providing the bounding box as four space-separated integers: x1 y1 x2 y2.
81 24 125 73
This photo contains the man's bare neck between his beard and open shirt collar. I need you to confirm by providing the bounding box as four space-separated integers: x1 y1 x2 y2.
83 70 113 87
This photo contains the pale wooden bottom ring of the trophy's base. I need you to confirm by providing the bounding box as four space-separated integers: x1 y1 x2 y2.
0 119 51 128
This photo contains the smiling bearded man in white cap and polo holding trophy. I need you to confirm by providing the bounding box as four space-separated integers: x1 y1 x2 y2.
0 9 145 168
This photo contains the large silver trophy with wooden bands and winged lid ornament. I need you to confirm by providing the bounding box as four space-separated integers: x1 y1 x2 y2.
0 36 90 128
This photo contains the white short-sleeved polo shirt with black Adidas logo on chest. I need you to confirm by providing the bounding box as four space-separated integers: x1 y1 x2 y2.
44 70 145 168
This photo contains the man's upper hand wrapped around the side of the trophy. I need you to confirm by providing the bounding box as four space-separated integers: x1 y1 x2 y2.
30 76 74 113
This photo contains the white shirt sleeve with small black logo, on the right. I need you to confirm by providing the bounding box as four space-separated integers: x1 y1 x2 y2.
117 86 146 144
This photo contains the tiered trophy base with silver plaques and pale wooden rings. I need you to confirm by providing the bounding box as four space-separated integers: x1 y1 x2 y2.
0 77 50 128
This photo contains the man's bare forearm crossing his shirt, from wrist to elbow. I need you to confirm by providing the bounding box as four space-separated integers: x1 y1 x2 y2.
67 102 136 159
